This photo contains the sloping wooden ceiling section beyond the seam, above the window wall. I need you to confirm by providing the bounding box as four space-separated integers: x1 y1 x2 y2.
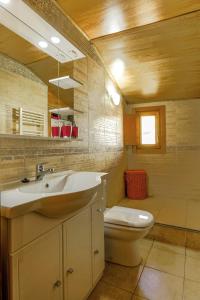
95 11 200 102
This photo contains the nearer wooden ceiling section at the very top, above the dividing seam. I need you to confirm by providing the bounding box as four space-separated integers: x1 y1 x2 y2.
56 0 200 39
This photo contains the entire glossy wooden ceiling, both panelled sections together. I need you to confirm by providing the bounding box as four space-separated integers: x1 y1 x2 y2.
57 0 200 103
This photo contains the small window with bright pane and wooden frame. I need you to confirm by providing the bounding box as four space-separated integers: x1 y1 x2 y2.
135 106 166 153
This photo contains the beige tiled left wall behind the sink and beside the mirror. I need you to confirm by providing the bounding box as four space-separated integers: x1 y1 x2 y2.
0 57 126 205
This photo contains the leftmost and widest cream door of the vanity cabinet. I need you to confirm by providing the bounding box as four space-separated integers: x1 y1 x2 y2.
10 226 63 300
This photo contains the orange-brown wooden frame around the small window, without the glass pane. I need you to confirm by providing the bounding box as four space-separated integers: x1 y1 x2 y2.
134 105 166 154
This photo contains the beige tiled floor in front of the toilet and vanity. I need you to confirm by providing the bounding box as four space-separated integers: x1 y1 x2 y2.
88 239 200 300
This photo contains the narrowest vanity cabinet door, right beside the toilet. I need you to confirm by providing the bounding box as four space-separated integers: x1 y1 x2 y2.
92 201 105 285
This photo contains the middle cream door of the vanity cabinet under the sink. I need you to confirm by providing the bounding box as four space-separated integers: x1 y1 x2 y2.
63 208 92 300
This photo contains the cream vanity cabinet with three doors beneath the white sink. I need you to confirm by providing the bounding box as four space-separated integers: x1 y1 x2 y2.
8 195 104 300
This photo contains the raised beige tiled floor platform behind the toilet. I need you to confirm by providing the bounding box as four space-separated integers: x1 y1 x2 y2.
119 196 200 230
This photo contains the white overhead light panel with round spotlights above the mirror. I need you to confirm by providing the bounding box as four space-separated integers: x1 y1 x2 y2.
0 0 85 63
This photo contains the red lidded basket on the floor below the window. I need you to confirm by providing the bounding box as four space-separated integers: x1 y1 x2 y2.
125 170 148 200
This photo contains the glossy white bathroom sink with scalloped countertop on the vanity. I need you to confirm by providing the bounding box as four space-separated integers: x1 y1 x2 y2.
1 171 106 218
